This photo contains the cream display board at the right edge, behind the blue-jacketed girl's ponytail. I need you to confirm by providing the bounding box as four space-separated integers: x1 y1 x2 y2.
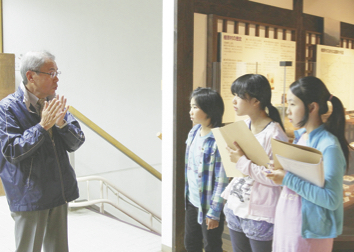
315 45 354 110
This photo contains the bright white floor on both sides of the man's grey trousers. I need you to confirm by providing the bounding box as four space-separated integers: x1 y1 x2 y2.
0 196 161 252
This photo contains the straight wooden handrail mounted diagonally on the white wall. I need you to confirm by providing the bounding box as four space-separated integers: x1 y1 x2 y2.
69 106 162 180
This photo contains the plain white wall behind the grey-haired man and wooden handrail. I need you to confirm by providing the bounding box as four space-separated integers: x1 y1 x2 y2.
3 0 162 229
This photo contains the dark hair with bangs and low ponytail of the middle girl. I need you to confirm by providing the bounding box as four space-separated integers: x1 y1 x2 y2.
231 74 285 131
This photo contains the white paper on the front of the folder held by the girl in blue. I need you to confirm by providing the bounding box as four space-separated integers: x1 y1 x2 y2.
275 154 324 187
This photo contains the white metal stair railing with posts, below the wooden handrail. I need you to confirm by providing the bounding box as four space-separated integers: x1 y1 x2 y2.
69 176 161 234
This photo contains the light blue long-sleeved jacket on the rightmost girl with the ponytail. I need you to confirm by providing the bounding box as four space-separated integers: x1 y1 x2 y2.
281 124 347 239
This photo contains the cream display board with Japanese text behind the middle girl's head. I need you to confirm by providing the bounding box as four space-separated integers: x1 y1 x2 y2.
219 32 296 123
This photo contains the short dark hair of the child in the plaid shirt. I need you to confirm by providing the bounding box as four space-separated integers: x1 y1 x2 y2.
190 87 224 128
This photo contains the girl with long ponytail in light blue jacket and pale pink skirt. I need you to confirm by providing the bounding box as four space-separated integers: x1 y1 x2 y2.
267 76 349 252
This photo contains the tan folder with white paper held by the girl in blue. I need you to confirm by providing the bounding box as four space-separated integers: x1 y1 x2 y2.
271 139 325 187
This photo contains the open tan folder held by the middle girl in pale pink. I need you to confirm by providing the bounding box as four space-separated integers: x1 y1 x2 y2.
212 121 269 177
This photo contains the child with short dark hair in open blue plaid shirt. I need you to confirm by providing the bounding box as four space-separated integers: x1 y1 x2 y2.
184 88 228 252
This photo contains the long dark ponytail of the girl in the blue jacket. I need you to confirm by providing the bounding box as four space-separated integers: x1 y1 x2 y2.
325 95 350 164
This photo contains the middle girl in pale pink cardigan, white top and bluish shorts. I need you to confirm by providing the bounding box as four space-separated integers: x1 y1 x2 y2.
222 74 288 252
